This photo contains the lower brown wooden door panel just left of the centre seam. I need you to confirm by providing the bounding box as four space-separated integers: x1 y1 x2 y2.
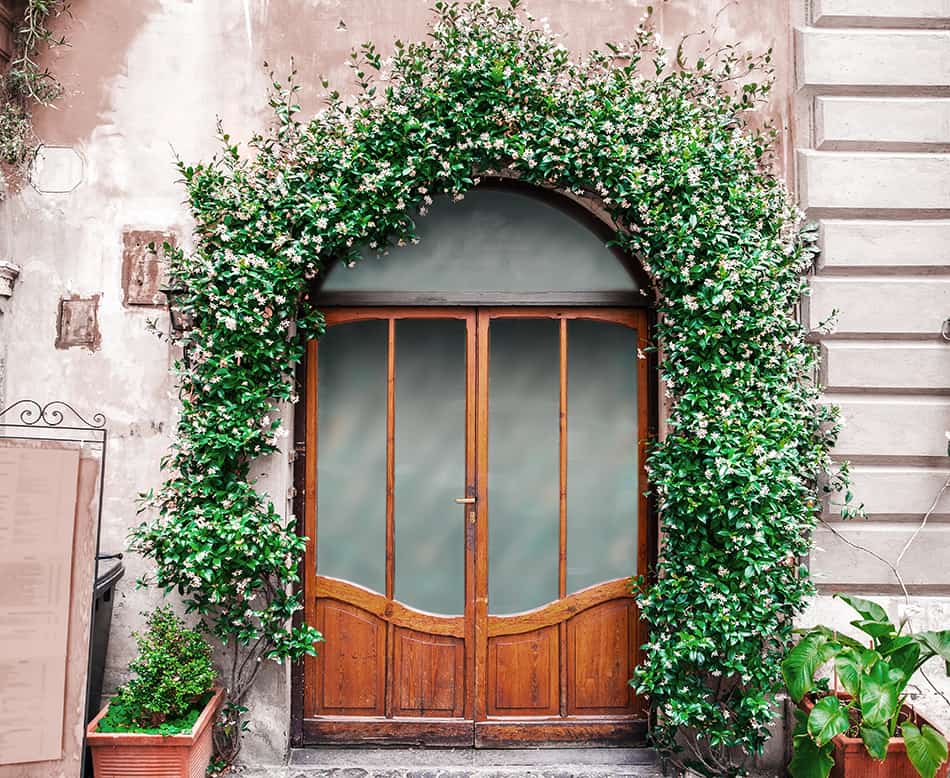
393 628 466 718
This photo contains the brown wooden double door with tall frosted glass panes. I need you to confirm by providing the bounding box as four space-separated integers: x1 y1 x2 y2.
302 307 647 746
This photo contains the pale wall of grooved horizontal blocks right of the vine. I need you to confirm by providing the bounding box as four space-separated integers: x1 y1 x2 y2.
793 0 950 728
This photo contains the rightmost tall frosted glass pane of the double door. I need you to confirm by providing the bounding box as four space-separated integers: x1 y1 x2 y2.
567 320 638 593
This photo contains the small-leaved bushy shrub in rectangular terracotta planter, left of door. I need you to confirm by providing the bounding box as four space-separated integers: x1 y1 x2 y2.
86 607 224 778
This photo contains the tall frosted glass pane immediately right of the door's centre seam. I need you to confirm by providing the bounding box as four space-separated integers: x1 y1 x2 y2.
488 319 560 613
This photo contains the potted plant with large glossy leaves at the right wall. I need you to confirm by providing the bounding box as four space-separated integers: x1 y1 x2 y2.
782 594 950 778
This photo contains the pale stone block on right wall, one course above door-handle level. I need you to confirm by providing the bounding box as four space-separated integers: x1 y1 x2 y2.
826 394 950 457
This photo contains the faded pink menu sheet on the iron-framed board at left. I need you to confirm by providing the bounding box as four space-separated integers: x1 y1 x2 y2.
0 441 80 765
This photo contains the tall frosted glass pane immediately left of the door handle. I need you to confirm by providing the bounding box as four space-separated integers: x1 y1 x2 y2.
394 319 465 614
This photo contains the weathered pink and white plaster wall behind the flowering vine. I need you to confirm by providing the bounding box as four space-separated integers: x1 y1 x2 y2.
0 0 792 763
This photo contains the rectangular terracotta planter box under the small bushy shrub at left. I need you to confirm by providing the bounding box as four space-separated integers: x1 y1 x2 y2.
86 688 224 778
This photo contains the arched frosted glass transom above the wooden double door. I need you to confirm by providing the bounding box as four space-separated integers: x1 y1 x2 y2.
321 189 637 292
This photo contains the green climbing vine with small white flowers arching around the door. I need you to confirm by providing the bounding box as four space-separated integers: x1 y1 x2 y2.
133 0 846 776
